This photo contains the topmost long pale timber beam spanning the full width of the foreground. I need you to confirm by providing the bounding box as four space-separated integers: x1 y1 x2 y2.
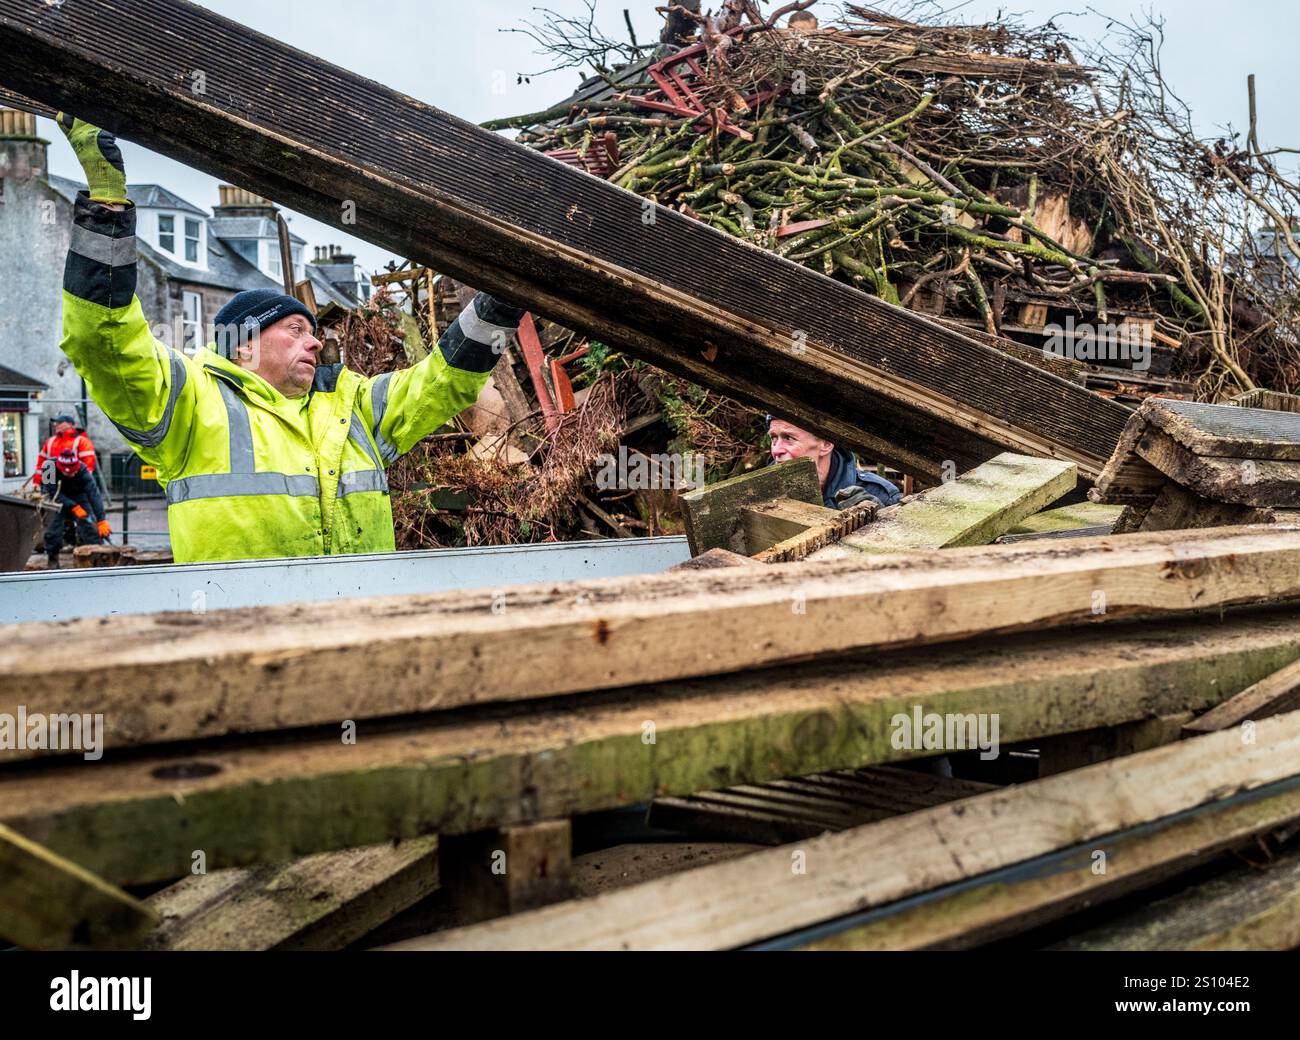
0 528 1300 754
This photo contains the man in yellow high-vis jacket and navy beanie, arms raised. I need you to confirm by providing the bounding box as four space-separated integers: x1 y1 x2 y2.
59 114 523 563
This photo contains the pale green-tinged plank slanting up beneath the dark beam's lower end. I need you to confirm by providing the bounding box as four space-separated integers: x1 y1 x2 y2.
810 452 1076 560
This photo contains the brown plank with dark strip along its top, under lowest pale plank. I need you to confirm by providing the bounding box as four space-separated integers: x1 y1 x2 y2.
783 780 1300 950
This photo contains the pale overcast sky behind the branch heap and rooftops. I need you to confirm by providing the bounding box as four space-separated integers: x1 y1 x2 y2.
42 0 1300 269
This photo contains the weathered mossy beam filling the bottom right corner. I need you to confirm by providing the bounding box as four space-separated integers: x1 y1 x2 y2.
1050 849 1300 952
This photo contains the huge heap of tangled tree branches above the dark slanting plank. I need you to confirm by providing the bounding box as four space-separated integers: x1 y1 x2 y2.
504 0 1300 399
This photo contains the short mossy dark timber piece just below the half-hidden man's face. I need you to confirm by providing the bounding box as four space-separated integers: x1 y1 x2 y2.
681 459 824 556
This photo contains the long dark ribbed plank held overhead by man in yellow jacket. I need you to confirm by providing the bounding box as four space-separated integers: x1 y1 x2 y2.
0 0 1128 480
